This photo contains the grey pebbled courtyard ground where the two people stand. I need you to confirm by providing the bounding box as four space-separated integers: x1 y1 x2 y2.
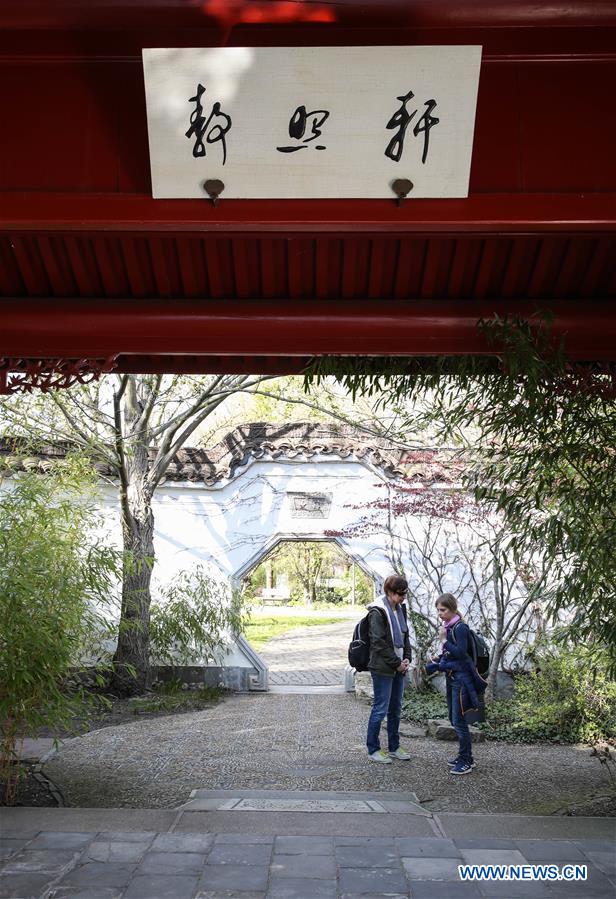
44 694 608 814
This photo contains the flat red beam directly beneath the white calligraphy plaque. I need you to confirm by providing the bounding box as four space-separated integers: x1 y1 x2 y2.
0 192 616 236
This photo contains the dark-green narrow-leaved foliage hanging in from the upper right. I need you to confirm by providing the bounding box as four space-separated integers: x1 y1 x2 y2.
307 317 616 671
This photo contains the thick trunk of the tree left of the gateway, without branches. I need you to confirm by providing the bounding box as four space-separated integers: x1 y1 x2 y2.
112 485 154 696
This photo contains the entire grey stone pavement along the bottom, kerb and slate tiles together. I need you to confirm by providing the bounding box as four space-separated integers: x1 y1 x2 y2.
0 794 616 899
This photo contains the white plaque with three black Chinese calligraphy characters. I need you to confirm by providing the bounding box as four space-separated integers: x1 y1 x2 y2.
143 46 481 199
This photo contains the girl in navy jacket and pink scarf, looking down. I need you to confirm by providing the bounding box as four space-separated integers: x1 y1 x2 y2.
426 593 486 774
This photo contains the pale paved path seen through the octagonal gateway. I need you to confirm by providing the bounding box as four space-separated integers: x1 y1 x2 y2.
259 624 356 687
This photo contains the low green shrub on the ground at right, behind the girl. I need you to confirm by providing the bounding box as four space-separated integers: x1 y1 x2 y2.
481 647 616 743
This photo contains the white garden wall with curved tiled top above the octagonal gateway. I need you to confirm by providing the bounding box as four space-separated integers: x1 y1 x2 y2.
2 425 532 689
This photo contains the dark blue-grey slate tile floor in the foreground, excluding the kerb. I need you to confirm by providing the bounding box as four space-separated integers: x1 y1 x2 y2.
0 809 616 899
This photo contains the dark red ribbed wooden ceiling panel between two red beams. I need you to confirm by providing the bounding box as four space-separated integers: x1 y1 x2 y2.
0 233 616 300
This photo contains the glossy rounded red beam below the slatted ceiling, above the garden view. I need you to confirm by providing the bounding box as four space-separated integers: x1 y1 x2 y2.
0 298 616 360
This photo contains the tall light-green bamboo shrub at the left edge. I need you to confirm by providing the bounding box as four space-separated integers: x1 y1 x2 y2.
0 458 121 804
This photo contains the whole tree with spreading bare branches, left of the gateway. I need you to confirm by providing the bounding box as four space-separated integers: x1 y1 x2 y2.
0 375 276 695
